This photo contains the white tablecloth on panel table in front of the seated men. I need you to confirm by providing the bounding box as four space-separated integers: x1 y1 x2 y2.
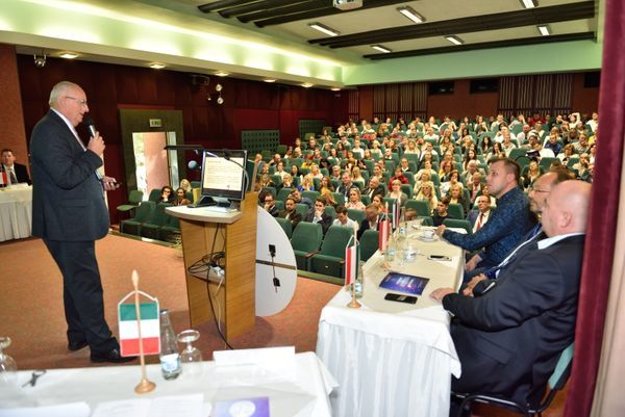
317 228 464 417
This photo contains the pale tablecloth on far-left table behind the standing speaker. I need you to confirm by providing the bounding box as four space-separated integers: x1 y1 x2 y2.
0 184 33 242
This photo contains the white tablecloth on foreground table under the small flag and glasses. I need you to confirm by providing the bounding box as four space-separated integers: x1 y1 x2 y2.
0 352 336 417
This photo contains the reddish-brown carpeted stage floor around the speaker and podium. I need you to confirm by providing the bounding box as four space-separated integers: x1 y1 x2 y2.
0 235 340 369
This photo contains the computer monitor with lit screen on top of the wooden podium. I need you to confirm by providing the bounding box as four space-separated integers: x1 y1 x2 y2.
198 149 247 206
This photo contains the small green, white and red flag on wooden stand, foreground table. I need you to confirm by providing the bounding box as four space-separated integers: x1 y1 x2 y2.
117 271 161 394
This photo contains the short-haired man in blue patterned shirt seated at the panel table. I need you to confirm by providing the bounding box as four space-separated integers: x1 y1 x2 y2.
436 158 536 280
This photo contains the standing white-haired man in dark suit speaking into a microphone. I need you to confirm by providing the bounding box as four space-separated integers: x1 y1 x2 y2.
30 81 131 362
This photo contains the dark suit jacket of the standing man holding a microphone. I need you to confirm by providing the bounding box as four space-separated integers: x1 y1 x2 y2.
30 110 109 241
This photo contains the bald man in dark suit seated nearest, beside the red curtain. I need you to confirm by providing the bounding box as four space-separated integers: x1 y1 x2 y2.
431 181 590 412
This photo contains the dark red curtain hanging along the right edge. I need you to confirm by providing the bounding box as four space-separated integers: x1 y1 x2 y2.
564 0 625 417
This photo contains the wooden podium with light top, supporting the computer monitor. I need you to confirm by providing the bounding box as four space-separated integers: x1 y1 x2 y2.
166 193 258 340
